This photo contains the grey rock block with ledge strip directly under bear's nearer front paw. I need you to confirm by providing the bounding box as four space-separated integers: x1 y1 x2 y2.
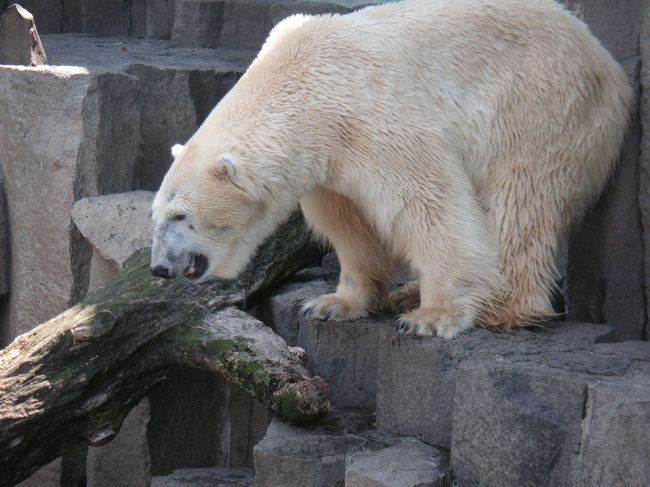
377 322 611 448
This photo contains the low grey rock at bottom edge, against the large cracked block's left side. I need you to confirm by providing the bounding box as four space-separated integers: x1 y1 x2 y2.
345 439 449 487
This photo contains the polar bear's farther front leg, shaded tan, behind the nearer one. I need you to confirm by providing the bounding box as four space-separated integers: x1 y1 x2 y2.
300 188 394 321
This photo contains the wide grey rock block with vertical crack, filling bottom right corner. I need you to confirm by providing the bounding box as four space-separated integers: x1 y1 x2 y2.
451 341 650 487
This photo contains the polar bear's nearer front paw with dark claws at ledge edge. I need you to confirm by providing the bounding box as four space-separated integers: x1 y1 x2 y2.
397 308 474 338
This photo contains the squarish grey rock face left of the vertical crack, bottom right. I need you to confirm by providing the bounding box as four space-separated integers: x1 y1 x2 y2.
451 361 586 487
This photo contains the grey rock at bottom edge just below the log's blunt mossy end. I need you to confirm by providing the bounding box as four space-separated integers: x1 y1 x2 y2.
255 419 368 487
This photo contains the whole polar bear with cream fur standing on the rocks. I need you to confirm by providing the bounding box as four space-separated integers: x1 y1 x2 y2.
152 0 633 338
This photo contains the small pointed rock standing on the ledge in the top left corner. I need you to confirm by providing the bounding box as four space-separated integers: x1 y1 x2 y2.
0 4 47 66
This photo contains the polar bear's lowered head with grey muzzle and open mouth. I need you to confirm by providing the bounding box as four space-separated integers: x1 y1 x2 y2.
151 140 268 282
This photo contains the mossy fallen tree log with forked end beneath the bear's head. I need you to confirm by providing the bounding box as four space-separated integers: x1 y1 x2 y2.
0 215 329 485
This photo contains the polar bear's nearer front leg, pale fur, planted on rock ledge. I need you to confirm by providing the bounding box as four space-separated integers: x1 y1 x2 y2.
393 191 502 338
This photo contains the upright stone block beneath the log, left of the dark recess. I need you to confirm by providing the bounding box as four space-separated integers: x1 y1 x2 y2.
86 398 150 487
